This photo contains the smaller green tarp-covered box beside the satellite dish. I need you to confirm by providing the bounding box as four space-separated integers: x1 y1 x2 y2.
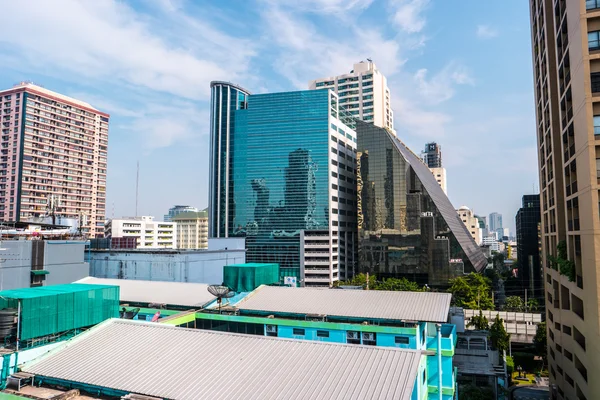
223 263 279 293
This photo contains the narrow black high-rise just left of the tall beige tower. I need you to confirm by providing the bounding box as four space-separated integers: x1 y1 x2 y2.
515 194 545 298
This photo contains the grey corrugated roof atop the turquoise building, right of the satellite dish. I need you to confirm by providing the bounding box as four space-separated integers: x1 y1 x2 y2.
235 286 452 322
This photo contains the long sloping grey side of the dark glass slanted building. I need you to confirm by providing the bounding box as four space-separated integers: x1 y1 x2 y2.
382 128 487 272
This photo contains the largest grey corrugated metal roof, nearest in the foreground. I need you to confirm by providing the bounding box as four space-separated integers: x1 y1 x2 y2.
23 320 421 400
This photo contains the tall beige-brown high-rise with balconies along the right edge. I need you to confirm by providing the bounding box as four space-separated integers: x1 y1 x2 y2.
529 0 600 400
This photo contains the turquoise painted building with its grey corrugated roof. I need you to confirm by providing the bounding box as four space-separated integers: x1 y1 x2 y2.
184 286 458 400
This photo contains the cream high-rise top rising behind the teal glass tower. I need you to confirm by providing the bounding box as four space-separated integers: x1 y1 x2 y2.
308 60 394 132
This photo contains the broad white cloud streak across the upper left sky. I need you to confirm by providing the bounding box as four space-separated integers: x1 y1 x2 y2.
0 0 254 99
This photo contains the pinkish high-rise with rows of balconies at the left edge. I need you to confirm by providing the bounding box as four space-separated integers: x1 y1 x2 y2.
0 82 109 237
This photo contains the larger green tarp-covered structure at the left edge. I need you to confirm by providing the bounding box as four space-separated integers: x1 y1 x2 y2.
0 283 119 340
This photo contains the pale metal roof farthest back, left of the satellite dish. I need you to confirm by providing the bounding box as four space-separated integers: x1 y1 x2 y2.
77 276 215 307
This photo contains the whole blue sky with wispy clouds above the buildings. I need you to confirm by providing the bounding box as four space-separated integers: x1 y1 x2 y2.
0 0 538 232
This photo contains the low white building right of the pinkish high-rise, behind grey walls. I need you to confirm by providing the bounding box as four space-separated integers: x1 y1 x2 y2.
106 216 177 249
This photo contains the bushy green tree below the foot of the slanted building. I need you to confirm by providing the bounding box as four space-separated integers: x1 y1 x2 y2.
448 273 494 310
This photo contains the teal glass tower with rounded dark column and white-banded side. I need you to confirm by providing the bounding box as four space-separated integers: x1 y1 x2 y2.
209 82 356 286
